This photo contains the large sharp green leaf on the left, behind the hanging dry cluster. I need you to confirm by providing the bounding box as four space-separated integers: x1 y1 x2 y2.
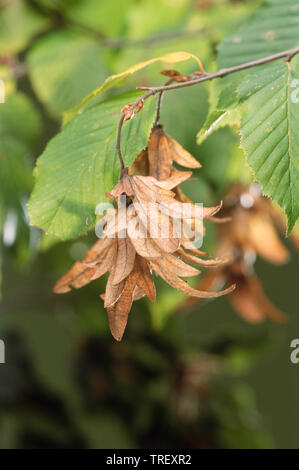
29 92 156 240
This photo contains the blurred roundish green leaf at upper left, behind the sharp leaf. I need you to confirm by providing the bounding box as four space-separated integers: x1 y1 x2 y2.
27 31 106 115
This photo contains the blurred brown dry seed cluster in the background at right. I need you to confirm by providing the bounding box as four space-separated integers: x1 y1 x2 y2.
178 184 299 323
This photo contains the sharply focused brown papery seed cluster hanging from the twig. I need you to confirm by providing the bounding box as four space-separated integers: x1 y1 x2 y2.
54 126 235 341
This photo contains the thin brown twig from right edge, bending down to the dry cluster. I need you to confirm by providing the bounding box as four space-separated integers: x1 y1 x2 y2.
116 47 299 170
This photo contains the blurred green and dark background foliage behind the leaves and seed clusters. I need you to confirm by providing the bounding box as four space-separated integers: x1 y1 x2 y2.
0 0 299 448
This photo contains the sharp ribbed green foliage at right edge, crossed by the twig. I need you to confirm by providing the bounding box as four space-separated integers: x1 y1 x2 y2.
198 0 299 228
